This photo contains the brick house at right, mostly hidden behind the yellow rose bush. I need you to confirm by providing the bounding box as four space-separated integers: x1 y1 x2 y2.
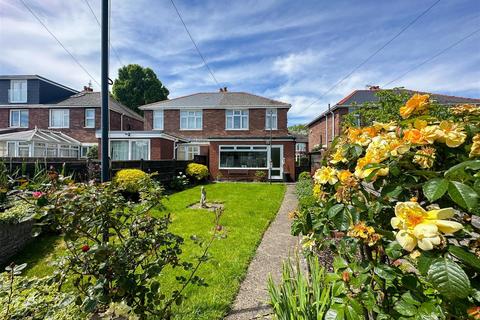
308 86 480 152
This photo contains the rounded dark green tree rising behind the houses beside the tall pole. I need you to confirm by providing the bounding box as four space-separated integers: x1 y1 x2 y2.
112 64 170 113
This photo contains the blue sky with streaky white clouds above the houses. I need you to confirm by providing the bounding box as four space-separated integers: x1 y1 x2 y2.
0 0 480 125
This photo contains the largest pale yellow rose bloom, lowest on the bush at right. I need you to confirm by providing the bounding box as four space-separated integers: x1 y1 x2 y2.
390 201 463 252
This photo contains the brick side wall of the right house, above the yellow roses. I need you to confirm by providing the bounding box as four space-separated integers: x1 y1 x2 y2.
308 108 348 151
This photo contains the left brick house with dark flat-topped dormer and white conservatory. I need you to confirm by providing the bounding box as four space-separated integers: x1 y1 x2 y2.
0 75 144 157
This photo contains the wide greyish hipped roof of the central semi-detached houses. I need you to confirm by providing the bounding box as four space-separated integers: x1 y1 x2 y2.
140 92 291 110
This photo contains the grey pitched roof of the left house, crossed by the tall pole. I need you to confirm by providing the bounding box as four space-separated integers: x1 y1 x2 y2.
55 91 143 121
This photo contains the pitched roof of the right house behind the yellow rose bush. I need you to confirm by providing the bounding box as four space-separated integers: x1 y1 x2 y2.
308 89 480 126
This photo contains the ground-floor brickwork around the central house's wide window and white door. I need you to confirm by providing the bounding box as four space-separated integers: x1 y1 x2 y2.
209 141 295 179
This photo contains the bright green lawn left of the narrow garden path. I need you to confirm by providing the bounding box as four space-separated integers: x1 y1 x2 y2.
7 183 285 319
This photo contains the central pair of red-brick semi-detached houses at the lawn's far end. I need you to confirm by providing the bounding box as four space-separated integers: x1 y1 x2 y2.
101 88 295 180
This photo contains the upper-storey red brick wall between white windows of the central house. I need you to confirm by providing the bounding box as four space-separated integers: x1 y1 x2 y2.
144 108 288 139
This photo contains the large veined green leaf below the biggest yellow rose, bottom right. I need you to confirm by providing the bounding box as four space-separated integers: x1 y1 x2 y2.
427 258 471 300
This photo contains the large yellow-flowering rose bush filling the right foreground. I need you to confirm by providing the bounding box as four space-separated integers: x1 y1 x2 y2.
292 94 480 319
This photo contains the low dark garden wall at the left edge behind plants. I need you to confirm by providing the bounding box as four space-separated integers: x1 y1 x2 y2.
0 221 33 266
